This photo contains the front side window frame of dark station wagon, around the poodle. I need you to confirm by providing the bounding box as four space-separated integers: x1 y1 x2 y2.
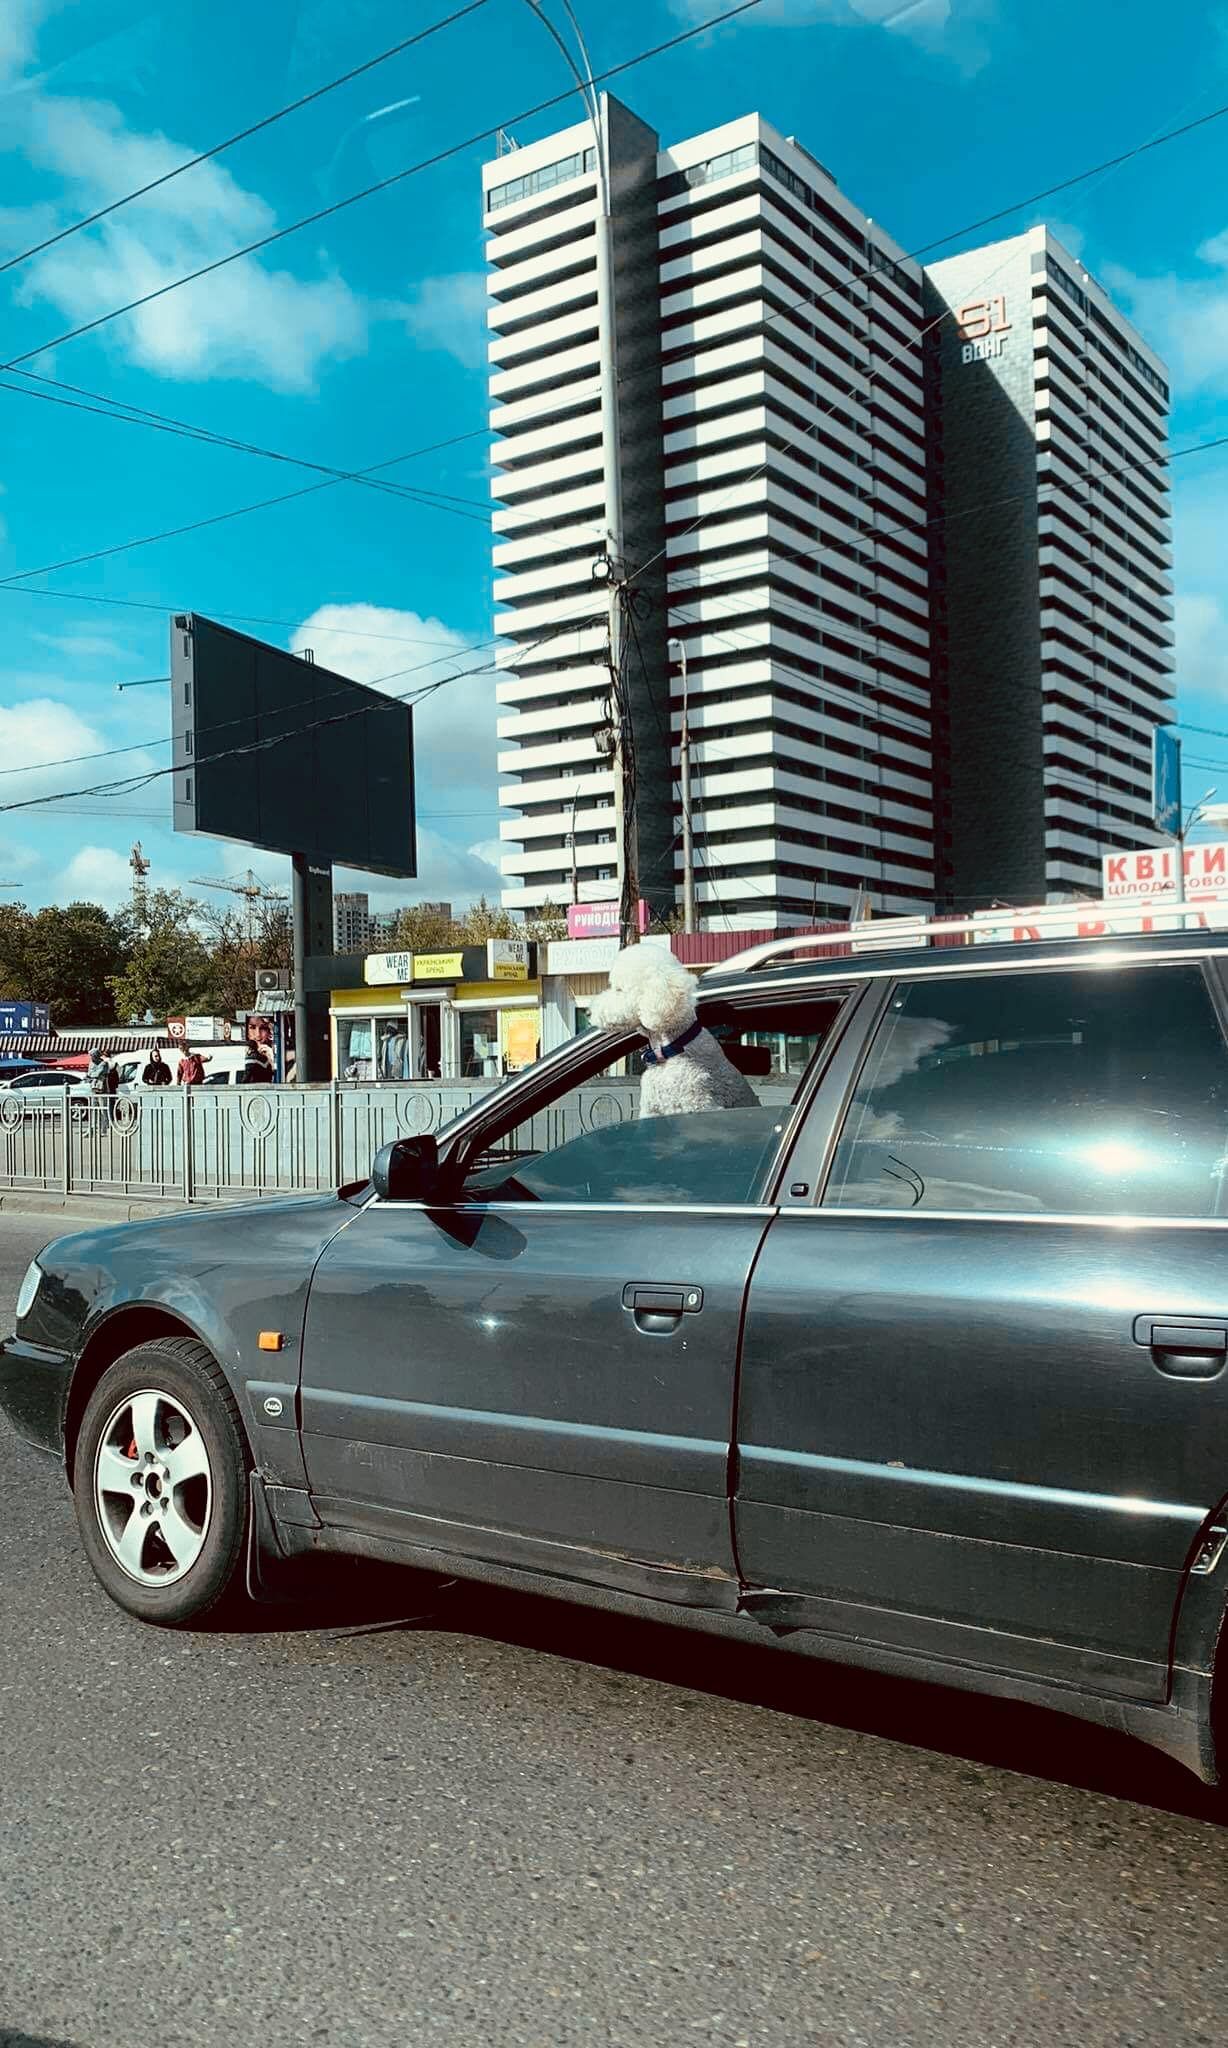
384 975 870 1214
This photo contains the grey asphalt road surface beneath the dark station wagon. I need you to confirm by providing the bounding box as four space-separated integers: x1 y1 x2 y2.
0 1217 1228 2048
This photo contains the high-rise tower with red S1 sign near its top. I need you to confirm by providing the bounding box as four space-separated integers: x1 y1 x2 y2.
927 227 1173 909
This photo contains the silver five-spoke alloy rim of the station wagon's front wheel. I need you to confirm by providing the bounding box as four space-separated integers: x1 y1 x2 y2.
94 1386 213 1585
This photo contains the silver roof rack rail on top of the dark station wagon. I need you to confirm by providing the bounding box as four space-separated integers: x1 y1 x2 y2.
702 897 1228 981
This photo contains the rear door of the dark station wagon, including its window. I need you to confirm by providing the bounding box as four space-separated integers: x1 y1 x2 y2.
735 954 1228 1698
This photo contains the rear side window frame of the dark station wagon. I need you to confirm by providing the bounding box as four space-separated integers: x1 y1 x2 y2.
802 950 1228 1231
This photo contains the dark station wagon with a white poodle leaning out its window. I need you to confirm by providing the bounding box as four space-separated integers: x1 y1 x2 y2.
0 934 1228 1780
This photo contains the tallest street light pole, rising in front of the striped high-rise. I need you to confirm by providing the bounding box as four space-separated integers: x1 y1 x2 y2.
526 0 639 946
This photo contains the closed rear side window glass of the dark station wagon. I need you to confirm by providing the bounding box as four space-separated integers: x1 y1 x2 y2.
825 965 1228 1217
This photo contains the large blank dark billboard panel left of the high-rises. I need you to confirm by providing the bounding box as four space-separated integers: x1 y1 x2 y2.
170 612 418 879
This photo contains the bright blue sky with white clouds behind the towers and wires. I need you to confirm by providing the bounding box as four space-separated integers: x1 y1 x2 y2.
0 0 1228 903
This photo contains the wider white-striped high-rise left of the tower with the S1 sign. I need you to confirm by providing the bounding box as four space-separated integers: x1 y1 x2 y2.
483 98 933 926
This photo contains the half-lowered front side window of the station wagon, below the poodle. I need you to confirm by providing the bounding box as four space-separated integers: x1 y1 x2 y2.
465 997 841 1206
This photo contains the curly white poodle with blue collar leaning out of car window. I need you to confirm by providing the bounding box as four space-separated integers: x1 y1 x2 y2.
589 946 759 1116
